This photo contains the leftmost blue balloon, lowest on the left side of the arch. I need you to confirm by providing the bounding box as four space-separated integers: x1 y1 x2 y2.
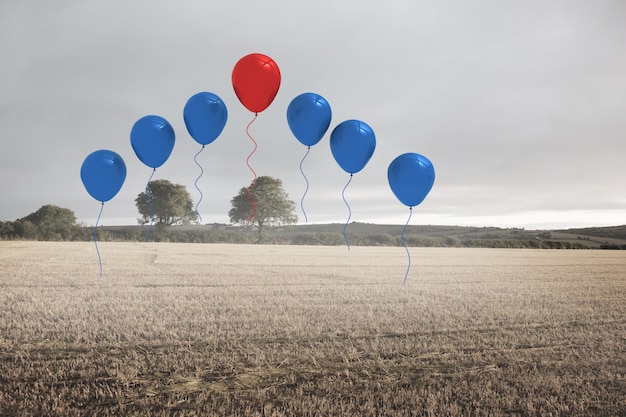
80 149 126 203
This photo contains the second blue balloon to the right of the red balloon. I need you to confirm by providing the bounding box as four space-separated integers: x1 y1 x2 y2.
330 120 376 174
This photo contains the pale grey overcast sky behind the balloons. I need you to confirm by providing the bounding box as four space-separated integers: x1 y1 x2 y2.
0 0 626 229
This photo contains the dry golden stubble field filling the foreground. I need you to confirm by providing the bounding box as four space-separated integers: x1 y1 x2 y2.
0 242 626 416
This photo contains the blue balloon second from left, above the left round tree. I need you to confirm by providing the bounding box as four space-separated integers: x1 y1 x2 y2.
130 116 175 168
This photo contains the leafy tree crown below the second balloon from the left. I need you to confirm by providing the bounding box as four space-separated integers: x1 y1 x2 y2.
135 180 198 226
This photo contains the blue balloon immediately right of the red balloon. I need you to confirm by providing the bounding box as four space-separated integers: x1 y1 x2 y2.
287 93 332 146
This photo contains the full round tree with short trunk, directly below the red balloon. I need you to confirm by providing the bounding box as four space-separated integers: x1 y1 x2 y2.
228 176 298 242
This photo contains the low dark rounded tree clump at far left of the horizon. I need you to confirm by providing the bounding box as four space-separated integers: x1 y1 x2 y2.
20 204 79 240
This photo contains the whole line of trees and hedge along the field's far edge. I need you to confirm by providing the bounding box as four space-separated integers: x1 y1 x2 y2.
0 176 626 249
